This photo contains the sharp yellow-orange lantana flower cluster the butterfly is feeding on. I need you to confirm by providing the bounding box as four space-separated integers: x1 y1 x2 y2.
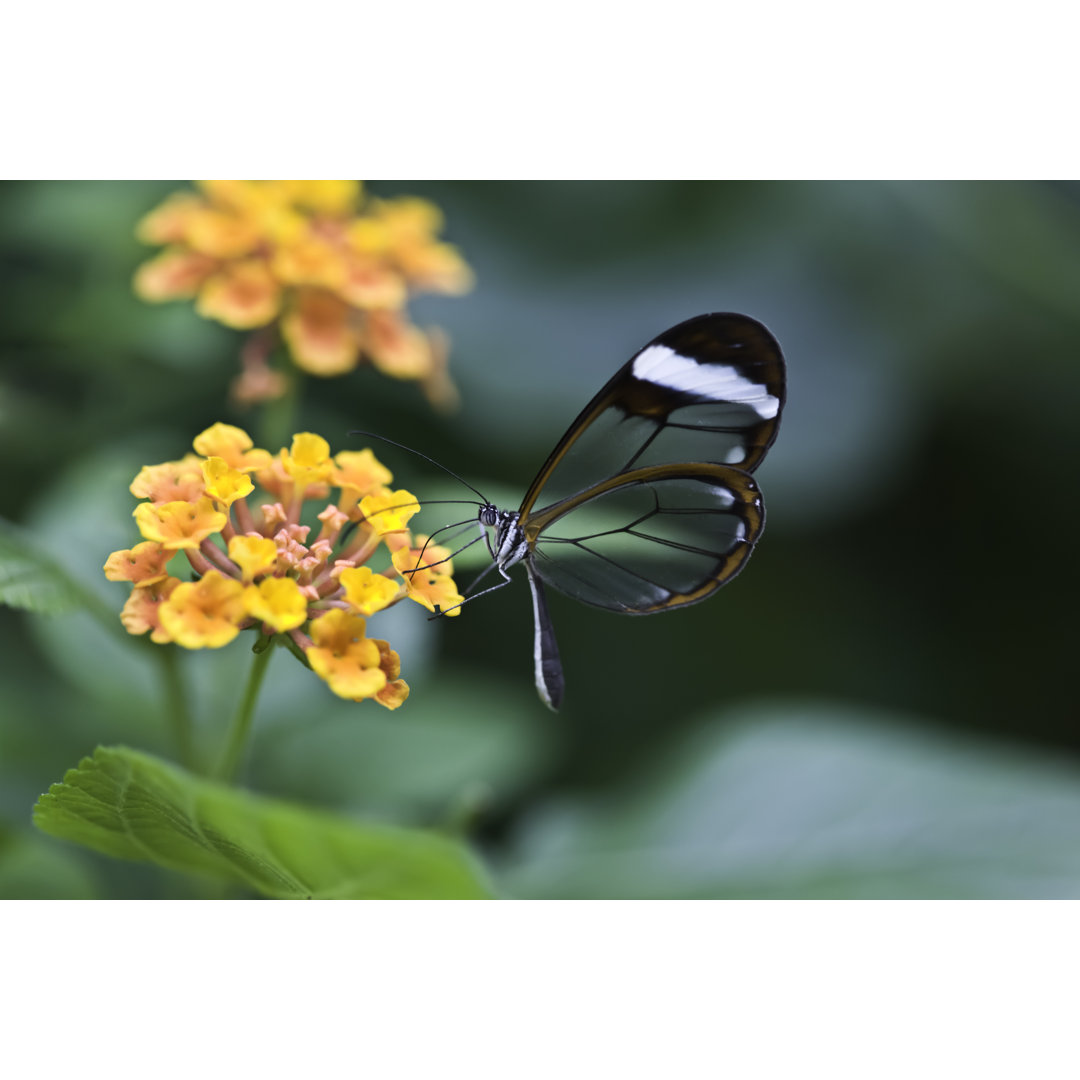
105 423 463 708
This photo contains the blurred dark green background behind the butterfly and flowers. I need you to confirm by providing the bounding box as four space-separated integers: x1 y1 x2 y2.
0 183 1080 897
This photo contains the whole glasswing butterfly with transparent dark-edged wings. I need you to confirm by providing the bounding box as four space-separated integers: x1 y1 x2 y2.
367 314 784 708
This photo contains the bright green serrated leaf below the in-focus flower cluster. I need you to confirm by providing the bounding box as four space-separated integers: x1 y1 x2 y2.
33 746 490 900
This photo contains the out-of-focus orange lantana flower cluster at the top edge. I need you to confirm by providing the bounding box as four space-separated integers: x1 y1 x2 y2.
135 180 472 404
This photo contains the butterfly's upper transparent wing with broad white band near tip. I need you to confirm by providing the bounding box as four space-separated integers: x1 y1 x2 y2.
521 314 784 518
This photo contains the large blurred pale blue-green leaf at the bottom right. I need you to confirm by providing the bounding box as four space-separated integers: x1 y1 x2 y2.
503 705 1080 899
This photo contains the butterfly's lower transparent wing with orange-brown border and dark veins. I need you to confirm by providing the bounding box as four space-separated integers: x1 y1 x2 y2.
525 464 765 615
